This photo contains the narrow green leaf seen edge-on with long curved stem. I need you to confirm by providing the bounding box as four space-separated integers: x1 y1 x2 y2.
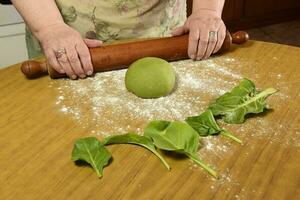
104 133 171 170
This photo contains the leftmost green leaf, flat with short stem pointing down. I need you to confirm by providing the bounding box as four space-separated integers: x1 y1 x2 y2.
72 137 111 177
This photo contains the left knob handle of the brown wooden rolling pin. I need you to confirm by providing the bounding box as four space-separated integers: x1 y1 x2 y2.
21 60 48 79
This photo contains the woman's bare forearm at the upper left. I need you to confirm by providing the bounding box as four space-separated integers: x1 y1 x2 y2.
12 0 64 36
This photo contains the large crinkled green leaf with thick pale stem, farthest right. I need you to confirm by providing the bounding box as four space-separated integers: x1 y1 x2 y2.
209 79 277 124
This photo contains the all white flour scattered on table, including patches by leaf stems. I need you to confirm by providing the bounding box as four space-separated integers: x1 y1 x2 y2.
53 56 300 199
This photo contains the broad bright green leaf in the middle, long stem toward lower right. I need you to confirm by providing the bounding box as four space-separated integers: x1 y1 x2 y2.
144 121 217 178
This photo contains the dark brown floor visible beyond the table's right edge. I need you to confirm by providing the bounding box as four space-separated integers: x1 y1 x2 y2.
246 20 300 47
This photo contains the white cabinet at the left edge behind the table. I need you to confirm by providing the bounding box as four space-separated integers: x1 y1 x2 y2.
0 5 28 68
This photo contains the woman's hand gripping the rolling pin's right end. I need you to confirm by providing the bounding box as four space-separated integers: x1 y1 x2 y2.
172 10 226 60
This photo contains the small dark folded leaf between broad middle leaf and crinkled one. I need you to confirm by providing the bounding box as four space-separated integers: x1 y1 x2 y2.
185 109 242 144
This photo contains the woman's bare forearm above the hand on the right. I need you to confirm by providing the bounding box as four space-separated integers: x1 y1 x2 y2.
193 0 225 17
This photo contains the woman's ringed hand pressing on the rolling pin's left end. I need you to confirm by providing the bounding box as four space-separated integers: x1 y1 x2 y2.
35 23 102 79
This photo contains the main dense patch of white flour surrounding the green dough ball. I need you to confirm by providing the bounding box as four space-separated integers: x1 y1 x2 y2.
56 58 242 135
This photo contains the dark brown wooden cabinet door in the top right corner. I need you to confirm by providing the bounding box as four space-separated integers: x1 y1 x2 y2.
245 0 300 17
